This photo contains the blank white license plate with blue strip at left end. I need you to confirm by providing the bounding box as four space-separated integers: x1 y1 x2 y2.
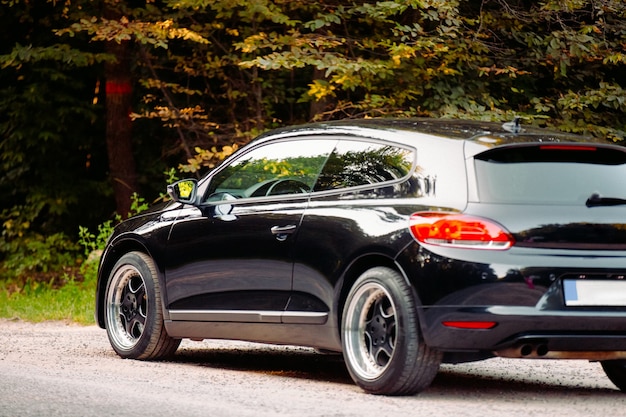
563 279 626 307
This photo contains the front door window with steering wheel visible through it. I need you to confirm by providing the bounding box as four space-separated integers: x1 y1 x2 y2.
204 139 337 201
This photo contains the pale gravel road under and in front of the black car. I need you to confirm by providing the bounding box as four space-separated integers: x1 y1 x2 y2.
0 320 626 417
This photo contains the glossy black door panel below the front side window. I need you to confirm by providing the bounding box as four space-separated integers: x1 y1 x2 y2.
165 197 307 311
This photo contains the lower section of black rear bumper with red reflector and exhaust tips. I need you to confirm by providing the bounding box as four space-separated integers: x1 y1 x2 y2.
423 306 626 360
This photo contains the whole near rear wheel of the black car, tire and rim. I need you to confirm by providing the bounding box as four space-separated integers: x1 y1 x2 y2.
341 267 442 395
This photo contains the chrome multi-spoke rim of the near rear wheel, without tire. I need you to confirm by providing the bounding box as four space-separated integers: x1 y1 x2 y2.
343 282 397 380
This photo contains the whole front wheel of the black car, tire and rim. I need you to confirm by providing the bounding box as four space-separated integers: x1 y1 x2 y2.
104 252 180 360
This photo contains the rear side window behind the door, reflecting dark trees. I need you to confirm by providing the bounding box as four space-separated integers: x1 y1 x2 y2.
314 140 415 191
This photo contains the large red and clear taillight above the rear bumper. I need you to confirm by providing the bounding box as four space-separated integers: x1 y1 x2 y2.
409 212 514 250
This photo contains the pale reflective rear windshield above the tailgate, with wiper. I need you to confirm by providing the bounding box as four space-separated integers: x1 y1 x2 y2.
475 144 626 204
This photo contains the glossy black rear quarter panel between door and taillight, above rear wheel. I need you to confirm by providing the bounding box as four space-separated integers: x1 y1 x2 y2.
293 198 420 308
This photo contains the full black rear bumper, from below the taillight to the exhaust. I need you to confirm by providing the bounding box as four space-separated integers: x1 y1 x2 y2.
397 245 626 360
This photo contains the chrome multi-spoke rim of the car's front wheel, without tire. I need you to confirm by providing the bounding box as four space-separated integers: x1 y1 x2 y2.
107 265 148 349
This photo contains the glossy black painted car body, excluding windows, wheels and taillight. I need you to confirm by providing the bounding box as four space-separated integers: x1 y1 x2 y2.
96 120 626 359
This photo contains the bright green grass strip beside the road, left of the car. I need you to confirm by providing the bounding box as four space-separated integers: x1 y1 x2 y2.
0 262 96 325
